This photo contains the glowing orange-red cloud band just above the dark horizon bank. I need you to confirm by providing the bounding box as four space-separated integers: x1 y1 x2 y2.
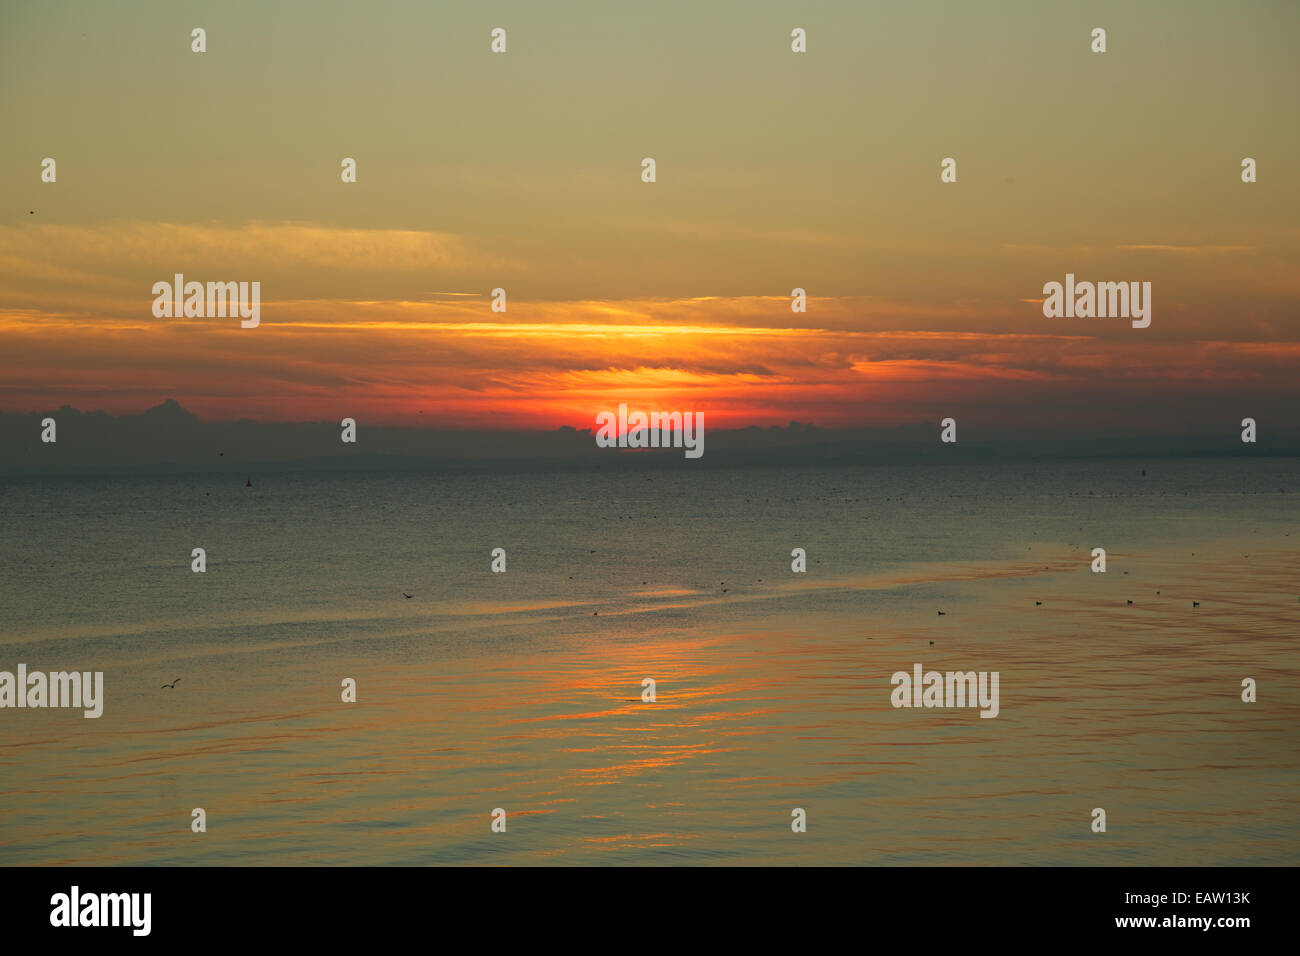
0 298 1300 428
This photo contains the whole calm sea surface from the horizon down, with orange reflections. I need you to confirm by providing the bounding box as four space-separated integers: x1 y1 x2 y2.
0 459 1300 865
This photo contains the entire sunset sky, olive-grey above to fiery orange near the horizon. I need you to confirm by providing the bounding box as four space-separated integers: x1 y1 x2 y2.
0 0 1300 434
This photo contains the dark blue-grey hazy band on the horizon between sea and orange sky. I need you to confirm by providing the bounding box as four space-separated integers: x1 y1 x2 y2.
0 398 1300 475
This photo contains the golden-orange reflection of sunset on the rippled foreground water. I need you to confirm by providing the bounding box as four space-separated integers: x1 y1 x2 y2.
0 538 1300 865
